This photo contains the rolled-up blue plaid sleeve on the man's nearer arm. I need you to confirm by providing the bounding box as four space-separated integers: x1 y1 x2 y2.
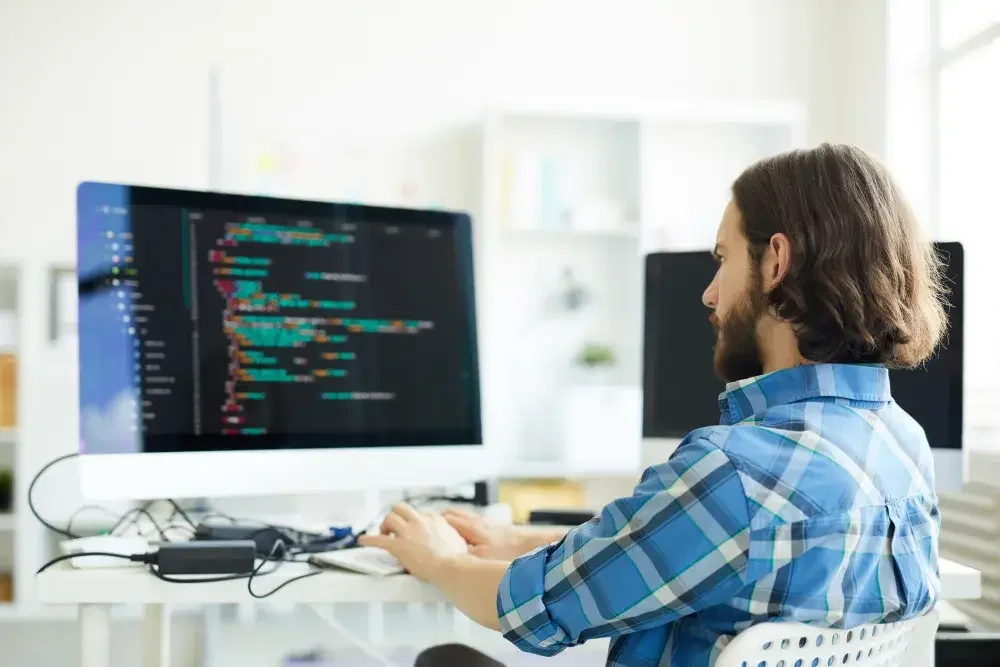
497 439 750 655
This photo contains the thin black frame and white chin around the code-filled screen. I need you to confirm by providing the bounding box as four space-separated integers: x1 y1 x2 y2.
77 181 487 498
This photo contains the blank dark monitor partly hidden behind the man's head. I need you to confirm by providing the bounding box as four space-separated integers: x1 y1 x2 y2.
643 243 965 491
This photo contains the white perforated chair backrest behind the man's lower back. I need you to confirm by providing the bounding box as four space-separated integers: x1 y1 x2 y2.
714 611 938 667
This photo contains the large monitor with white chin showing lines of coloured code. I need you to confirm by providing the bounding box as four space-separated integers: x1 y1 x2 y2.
78 183 489 499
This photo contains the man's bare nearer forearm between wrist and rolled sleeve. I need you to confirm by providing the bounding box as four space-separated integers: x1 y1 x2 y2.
431 555 510 630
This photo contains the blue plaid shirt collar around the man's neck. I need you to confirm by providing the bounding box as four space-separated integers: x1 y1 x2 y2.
719 364 891 424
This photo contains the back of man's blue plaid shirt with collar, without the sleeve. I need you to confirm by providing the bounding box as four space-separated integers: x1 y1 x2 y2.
648 366 939 665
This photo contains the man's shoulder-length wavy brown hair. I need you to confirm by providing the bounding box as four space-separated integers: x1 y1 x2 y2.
732 144 947 368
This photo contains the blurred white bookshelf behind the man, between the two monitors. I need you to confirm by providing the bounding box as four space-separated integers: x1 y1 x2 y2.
476 99 805 478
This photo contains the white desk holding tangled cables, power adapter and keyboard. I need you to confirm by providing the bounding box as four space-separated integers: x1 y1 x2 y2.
37 560 981 667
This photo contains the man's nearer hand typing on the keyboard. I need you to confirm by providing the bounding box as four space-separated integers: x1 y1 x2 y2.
358 503 469 583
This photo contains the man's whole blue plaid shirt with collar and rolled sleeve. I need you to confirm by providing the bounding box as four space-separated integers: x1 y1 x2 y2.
497 364 940 667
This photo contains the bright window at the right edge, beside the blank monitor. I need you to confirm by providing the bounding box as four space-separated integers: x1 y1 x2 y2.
928 0 1000 447
